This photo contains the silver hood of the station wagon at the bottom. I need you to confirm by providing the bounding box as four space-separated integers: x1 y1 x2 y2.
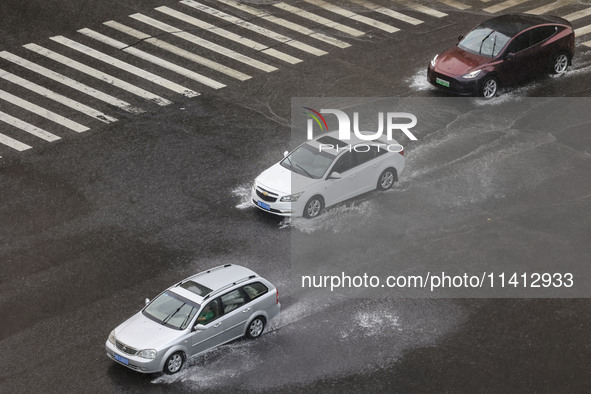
115 312 182 350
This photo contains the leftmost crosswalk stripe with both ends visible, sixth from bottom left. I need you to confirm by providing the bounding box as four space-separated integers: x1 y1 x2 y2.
23 44 172 106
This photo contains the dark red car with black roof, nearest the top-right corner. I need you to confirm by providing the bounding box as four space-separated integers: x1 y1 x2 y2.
427 14 575 98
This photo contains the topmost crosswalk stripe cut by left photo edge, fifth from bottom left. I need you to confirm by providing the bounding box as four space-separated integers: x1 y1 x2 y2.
0 51 144 114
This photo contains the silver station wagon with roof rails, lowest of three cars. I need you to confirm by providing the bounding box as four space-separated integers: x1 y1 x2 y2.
105 264 281 374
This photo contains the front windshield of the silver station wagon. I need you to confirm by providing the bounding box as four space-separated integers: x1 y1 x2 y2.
143 292 199 330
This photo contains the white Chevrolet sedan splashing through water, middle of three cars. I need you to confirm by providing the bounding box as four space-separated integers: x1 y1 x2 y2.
251 131 404 218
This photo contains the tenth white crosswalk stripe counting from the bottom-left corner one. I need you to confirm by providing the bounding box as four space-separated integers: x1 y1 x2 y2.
130 14 277 72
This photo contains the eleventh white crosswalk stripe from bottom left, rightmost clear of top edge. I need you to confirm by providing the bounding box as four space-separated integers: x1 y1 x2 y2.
156 7 302 64
